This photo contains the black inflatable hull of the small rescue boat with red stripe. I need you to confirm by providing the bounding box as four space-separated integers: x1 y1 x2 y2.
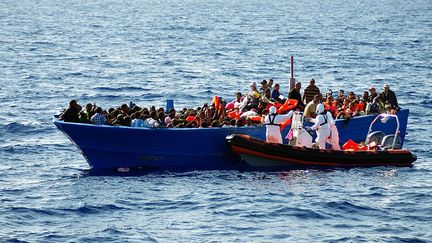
226 134 417 169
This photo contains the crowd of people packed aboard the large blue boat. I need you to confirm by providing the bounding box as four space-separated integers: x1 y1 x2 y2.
59 79 399 128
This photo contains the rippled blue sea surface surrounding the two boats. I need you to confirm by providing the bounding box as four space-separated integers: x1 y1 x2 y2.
0 0 432 242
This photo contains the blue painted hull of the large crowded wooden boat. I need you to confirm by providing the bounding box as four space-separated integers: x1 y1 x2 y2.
54 109 409 170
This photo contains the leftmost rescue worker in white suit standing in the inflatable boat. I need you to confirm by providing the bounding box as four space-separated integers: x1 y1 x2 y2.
264 106 293 143
